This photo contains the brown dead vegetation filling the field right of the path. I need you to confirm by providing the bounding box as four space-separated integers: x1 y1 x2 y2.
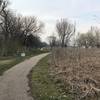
51 48 100 100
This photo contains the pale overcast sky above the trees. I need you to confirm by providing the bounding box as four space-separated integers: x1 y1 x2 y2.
10 0 100 40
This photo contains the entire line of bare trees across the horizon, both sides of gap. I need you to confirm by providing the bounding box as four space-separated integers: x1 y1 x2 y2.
0 0 100 56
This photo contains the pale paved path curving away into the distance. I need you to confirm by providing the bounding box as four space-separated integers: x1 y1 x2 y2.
0 53 47 100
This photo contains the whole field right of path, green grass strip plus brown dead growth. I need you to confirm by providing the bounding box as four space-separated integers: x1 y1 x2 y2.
29 48 100 100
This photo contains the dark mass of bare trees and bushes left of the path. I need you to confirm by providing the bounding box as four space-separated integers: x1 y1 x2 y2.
0 0 44 56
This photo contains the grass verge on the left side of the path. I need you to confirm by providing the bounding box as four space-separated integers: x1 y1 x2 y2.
0 49 48 75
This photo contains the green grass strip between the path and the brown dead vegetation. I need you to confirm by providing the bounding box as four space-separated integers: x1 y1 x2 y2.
29 56 71 100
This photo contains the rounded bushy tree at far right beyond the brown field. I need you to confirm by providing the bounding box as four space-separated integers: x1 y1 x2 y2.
77 27 100 48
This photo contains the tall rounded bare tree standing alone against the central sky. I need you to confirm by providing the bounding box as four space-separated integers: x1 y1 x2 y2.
56 19 75 47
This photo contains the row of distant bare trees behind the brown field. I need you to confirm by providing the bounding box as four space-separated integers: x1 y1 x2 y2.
48 19 100 48
